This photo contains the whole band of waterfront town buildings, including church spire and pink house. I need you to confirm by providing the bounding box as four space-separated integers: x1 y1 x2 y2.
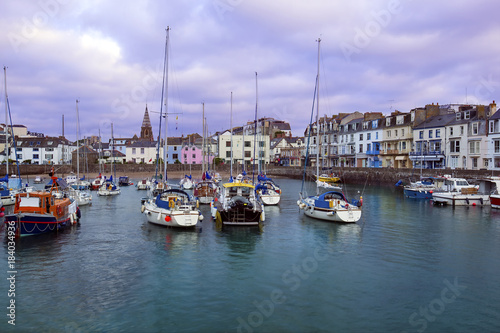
0 101 500 170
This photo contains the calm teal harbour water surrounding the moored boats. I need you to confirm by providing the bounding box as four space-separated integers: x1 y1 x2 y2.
0 179 500 332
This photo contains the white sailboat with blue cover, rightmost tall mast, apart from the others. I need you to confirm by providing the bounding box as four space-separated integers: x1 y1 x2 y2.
297 39 363 223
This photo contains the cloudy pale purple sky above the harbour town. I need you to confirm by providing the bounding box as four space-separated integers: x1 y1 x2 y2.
0 0 500 140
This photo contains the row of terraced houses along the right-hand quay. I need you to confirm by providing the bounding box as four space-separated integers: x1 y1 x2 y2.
298 101 500 170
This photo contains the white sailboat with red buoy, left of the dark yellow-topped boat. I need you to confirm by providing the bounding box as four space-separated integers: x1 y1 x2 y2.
141 27 203 227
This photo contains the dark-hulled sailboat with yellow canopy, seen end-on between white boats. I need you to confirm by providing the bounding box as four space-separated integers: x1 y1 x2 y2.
211 88 265 228
